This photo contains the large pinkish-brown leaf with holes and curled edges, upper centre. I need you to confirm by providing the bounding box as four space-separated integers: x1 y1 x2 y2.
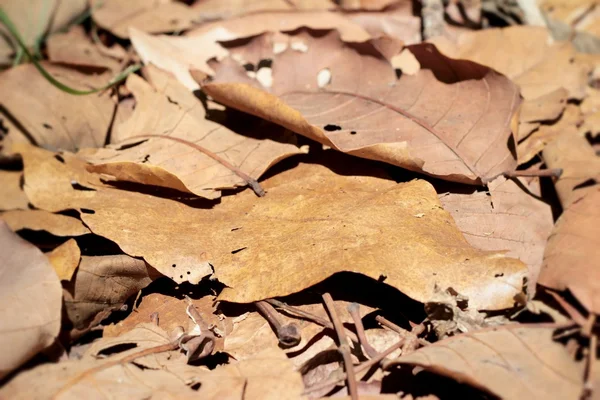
203 30 519 183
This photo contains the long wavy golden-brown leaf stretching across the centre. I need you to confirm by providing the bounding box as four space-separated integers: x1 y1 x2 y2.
20 146 526 309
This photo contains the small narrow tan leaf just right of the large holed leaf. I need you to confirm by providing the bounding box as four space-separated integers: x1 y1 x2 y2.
517 104 582 164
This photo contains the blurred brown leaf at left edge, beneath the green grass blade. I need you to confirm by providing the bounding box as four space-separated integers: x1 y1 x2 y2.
0 63 115 150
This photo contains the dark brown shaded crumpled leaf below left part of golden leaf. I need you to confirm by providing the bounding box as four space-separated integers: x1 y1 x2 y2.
63 255 160 332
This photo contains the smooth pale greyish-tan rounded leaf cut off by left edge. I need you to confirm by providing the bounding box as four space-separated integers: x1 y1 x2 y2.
0 221 62 379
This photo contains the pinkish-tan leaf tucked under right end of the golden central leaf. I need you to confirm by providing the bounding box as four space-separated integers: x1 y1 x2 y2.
440 177 553 288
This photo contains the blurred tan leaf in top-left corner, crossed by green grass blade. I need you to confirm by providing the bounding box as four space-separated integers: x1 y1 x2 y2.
0 0 87 65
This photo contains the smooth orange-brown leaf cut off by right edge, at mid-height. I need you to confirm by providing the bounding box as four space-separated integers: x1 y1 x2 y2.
539 185 600 313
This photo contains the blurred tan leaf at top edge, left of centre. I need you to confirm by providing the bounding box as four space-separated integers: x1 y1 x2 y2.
90 0 198 39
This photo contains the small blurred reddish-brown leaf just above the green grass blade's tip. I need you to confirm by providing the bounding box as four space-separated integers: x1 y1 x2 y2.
46 25 127 73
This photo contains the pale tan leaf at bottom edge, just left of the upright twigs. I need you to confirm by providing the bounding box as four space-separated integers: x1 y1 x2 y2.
193 347 304 400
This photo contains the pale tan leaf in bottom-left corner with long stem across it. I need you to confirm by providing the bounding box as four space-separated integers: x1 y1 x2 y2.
0 324 202 400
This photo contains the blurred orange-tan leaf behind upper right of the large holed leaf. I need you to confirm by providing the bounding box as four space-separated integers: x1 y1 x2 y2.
431 26 591 100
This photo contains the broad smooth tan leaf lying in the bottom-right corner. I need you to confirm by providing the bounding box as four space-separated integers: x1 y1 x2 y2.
384 325 584 400
